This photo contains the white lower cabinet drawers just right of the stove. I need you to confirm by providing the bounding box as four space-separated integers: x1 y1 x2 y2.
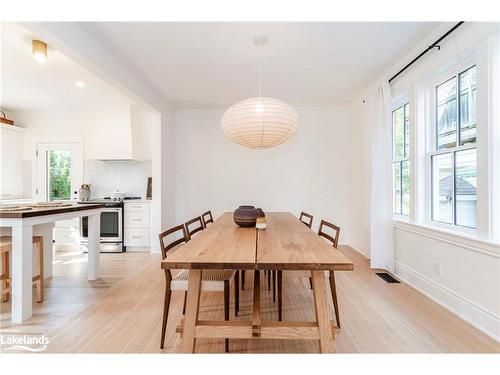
123 202 150 251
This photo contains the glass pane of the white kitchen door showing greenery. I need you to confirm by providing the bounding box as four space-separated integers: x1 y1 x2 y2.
47 151 71 201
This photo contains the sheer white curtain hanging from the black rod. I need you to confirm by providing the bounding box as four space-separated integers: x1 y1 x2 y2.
365 81 394 272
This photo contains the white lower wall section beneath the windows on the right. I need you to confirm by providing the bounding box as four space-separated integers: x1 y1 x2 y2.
394 225 500 341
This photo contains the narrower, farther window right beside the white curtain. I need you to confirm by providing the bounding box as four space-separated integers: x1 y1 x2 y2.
392 103 410 216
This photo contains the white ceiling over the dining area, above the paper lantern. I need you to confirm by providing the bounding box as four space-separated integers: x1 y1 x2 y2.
81 22 438 107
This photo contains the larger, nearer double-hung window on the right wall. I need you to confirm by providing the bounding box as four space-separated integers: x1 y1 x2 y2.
430 66 477 228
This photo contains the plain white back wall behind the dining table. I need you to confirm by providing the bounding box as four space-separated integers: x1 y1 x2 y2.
174 107 349 243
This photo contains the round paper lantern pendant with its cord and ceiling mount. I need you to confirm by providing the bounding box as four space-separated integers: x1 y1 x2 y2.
221 35 299 149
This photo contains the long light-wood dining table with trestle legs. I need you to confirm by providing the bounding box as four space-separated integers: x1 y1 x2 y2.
161 212 354 353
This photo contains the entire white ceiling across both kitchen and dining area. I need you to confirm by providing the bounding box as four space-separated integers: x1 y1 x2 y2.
0 22 438 110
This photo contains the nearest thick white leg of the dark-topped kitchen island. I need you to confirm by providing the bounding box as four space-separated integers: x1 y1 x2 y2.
11 225 33 323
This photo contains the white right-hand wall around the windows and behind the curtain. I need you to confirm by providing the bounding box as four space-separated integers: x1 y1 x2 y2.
349 23 500 341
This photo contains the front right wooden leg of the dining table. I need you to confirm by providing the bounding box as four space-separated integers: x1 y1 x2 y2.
312 271 334 353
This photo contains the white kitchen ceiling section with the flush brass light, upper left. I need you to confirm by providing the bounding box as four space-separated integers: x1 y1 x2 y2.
0 23 135 111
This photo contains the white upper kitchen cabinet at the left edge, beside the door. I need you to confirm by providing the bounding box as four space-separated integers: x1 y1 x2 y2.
0 124 25 199
